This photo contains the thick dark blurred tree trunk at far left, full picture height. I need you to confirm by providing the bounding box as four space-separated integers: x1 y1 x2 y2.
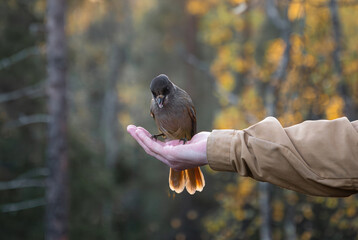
45 0 68 240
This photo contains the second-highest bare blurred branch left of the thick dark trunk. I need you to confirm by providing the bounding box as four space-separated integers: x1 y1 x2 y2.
0 81 45 103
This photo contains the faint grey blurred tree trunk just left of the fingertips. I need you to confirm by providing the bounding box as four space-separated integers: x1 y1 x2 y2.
101 1 128 234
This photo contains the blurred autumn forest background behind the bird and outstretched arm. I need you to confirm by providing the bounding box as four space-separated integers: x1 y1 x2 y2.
0 0 358 240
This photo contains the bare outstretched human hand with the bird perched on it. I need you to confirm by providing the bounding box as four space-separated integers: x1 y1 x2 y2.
127 125 210 170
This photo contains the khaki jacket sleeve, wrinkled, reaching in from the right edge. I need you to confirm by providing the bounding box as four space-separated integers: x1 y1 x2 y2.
207 117 358 197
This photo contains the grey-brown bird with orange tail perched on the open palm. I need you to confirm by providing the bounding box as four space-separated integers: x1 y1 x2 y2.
150 74 205 195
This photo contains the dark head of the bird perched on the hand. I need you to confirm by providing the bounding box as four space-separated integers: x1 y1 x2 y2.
150 74 175 108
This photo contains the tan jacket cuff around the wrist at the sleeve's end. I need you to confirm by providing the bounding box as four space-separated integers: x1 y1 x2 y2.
206 130 235 172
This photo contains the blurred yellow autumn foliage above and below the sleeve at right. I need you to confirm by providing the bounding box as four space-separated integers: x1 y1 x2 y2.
187 0 358 239
